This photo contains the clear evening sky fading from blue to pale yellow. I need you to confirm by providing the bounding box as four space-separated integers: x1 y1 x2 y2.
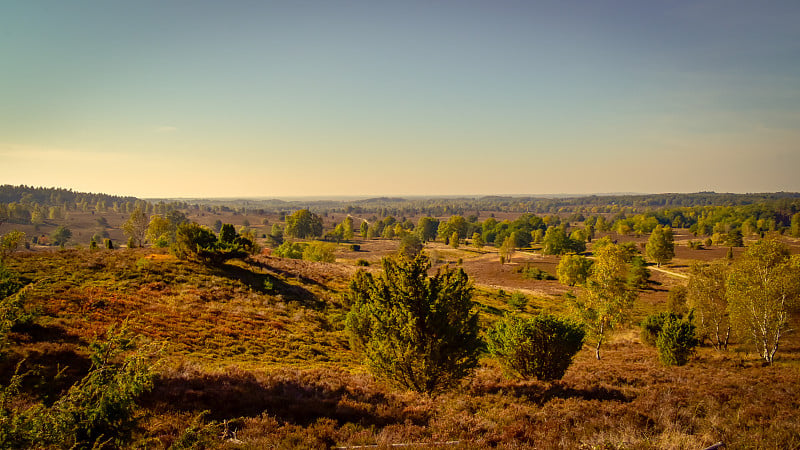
0 0 800 198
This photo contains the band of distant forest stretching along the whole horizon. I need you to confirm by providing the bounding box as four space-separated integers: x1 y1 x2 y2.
0 185 800 243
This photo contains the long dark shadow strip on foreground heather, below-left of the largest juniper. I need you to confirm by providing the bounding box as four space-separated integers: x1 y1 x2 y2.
143 373 412 426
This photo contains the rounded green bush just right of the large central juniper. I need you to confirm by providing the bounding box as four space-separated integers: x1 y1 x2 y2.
487 314 585 381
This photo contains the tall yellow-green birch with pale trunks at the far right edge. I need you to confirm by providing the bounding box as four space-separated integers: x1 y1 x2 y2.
727 239 800 364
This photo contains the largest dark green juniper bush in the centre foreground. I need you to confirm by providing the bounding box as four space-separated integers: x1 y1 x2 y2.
346 254 480 393
